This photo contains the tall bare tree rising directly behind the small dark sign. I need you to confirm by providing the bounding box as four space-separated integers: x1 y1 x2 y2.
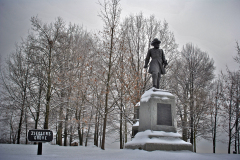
31 17 64 129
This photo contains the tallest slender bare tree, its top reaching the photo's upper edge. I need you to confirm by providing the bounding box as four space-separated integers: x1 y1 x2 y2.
96 0 121 149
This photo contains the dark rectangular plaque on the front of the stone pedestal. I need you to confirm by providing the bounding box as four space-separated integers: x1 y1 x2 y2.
157 103 172 126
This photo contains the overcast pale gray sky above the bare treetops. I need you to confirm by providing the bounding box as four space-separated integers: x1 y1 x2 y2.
0 0 240 152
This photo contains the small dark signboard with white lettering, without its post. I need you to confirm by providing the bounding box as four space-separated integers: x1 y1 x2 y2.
28 129 53 142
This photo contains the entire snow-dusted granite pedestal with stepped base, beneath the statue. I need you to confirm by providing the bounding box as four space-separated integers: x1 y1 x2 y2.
125 89 192 151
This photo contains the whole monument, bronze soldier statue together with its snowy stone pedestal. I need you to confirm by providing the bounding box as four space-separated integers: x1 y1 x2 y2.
125 39 192 151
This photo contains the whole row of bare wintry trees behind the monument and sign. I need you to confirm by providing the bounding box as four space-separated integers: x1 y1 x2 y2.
0 0 240 153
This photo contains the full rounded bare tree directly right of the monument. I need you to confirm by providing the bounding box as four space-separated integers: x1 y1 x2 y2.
171 44 215 151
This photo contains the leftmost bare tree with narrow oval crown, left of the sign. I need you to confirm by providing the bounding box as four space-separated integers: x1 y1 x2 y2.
2 43 30 144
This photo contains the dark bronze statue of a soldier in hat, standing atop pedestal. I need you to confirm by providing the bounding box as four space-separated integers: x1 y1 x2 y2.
144 38 168 89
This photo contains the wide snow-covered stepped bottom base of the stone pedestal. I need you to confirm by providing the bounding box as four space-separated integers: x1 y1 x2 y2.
125 130 192 151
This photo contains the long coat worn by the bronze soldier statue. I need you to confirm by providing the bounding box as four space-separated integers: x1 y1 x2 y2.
145 48 166 74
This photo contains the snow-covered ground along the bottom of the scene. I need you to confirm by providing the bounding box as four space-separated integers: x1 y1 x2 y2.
0 143 240 160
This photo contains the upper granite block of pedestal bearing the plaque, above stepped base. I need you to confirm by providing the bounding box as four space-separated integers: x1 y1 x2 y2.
138 88 177 132
